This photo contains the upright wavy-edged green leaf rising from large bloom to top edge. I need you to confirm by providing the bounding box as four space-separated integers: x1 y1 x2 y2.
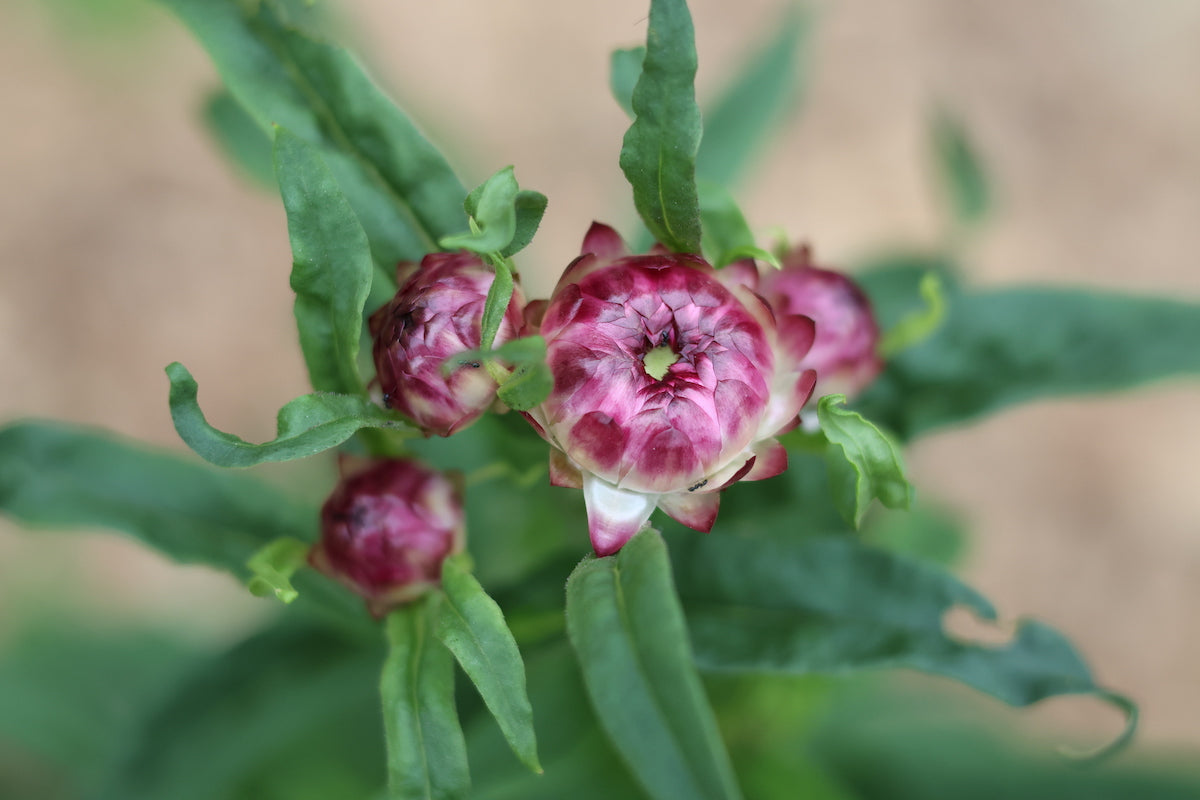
620 0 701 253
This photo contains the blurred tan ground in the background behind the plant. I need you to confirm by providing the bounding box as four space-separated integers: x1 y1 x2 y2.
0 0 1200 746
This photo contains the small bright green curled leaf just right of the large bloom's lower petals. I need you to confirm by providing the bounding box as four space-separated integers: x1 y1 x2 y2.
817 395 912 528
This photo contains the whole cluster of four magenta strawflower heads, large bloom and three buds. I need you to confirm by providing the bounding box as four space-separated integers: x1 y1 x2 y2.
328 223 882 587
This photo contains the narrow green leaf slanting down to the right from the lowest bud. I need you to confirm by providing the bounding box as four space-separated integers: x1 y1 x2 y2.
436 554 542 772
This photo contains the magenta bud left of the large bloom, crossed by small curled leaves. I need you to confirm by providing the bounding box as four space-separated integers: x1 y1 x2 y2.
370 252 524 437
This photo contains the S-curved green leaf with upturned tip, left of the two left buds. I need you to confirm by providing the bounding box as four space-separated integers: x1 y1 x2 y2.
167 361 415 467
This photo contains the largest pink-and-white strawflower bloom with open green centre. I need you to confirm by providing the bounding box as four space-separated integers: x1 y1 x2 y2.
527 223 815 555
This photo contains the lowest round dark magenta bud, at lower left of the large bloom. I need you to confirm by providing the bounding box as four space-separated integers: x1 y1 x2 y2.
308 459 464 616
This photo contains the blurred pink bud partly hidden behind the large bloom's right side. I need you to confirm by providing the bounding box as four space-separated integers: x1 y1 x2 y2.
758 246 883 397
